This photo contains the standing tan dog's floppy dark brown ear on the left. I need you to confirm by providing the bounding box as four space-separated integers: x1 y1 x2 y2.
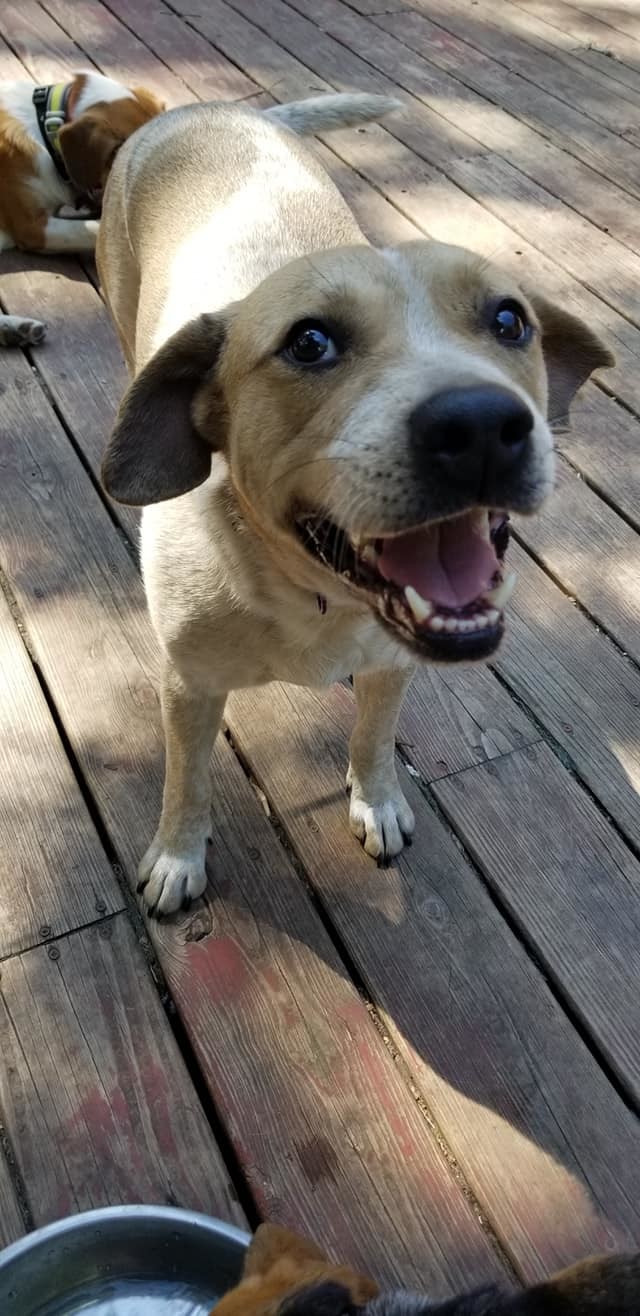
101 315 225 507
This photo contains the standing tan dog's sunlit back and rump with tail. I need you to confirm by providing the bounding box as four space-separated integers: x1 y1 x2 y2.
97 95 396 368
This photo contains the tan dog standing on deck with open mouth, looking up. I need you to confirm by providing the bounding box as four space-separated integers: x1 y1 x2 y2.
97 96 612 913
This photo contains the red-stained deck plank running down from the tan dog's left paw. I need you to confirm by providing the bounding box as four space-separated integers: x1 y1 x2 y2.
153 740 499 1292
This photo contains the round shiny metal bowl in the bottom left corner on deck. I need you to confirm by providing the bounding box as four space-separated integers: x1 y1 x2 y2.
0 1207 249 1316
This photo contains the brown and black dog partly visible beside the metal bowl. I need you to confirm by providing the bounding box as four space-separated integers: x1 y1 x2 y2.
211 1224 640 1316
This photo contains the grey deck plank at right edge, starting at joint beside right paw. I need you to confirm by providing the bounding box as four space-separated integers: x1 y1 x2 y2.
435 745 640 1101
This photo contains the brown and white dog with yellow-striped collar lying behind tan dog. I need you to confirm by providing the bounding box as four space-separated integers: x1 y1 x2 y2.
0 72 165 346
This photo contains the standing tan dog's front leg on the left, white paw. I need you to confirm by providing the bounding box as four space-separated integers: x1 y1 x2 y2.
138 665 225 916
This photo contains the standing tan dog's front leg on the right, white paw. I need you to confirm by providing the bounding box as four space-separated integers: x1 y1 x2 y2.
346 667 415 862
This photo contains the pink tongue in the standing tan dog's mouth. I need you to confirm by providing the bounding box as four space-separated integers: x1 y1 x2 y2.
378 516 498 608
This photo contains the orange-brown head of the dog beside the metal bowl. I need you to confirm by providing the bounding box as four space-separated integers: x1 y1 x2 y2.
212 1224 378 1316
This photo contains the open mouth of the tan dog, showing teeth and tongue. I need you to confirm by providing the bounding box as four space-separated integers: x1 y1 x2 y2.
296 508 515 662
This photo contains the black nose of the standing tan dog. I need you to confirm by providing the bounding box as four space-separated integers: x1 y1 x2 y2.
408 384 533 500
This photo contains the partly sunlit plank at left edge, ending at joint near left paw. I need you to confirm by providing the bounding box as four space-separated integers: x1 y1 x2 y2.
0 586 122 957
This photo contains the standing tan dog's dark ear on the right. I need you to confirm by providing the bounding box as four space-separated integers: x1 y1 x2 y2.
529 293 615 421
